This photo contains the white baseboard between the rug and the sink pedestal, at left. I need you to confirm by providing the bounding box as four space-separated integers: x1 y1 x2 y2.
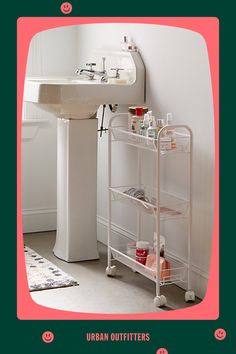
22 208 57 233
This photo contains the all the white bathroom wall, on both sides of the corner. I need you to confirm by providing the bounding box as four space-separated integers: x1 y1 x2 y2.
22 24 214 297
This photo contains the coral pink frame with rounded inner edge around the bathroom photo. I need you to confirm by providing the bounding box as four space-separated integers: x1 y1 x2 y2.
17 17 219 320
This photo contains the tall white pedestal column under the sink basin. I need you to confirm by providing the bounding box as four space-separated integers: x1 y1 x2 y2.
53 119 99 262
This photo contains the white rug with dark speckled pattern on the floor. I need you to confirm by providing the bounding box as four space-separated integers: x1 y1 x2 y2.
24 246 79 291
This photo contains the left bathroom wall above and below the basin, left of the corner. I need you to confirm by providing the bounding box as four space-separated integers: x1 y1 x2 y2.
22 27 77 232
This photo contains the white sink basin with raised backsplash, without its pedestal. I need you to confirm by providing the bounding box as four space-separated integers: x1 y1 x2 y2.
24 52 145 119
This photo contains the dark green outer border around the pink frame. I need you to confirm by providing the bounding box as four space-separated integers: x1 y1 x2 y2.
1 0 236 354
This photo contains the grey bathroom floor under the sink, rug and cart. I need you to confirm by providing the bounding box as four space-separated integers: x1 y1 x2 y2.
24 232 199 313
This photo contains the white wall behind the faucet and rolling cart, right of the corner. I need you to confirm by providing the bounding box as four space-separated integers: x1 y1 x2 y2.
78 24 214 297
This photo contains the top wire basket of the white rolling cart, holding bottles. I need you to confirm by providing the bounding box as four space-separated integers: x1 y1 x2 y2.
110 126 190 155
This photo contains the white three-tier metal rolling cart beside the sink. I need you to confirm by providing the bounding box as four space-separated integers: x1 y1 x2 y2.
105 113 195 307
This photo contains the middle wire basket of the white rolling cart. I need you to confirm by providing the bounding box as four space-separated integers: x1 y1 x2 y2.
110 186 189 220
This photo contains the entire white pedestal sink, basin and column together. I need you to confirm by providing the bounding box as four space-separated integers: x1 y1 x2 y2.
24 51 145 262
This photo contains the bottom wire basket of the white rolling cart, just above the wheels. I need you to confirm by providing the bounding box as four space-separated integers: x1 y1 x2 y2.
110 236 187 286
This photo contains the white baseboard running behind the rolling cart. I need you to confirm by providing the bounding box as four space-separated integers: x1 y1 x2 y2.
97 216 208 299
